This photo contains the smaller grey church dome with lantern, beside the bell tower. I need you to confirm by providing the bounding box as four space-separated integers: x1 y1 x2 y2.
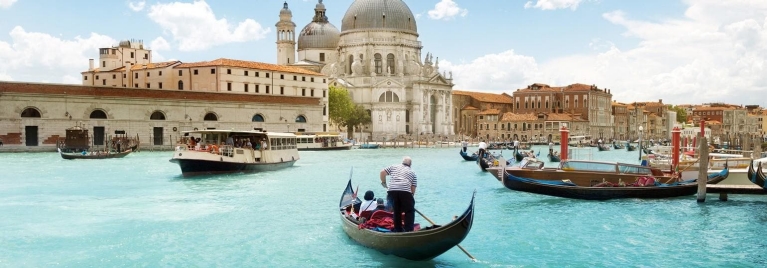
298 0 341 50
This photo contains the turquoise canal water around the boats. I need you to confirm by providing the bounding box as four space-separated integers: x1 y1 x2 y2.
0 146 767 267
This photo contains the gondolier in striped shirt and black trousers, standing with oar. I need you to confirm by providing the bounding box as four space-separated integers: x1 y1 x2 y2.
381 156 418 232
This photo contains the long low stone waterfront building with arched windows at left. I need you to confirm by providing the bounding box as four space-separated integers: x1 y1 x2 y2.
0 82 324 151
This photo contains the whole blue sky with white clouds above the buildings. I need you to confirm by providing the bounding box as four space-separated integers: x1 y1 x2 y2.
0 0 767 107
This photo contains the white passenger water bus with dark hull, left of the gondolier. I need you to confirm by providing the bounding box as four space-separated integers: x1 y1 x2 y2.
170 129 299 176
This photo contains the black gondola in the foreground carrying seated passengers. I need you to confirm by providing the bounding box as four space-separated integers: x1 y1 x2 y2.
339 179 474 261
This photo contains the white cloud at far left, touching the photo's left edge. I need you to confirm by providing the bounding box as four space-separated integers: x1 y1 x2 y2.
0 26 117 83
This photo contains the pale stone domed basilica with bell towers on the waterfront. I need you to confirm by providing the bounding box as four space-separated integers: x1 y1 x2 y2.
275 0 454 141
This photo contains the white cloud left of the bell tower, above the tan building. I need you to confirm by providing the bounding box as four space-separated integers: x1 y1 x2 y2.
148 1 270 51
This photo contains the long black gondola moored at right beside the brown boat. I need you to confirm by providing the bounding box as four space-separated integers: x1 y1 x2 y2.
502 168 729 200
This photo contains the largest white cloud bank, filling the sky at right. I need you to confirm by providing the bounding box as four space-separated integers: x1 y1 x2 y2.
445 0 767 106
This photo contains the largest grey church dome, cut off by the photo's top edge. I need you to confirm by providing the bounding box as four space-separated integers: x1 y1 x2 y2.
341 0 418 34
